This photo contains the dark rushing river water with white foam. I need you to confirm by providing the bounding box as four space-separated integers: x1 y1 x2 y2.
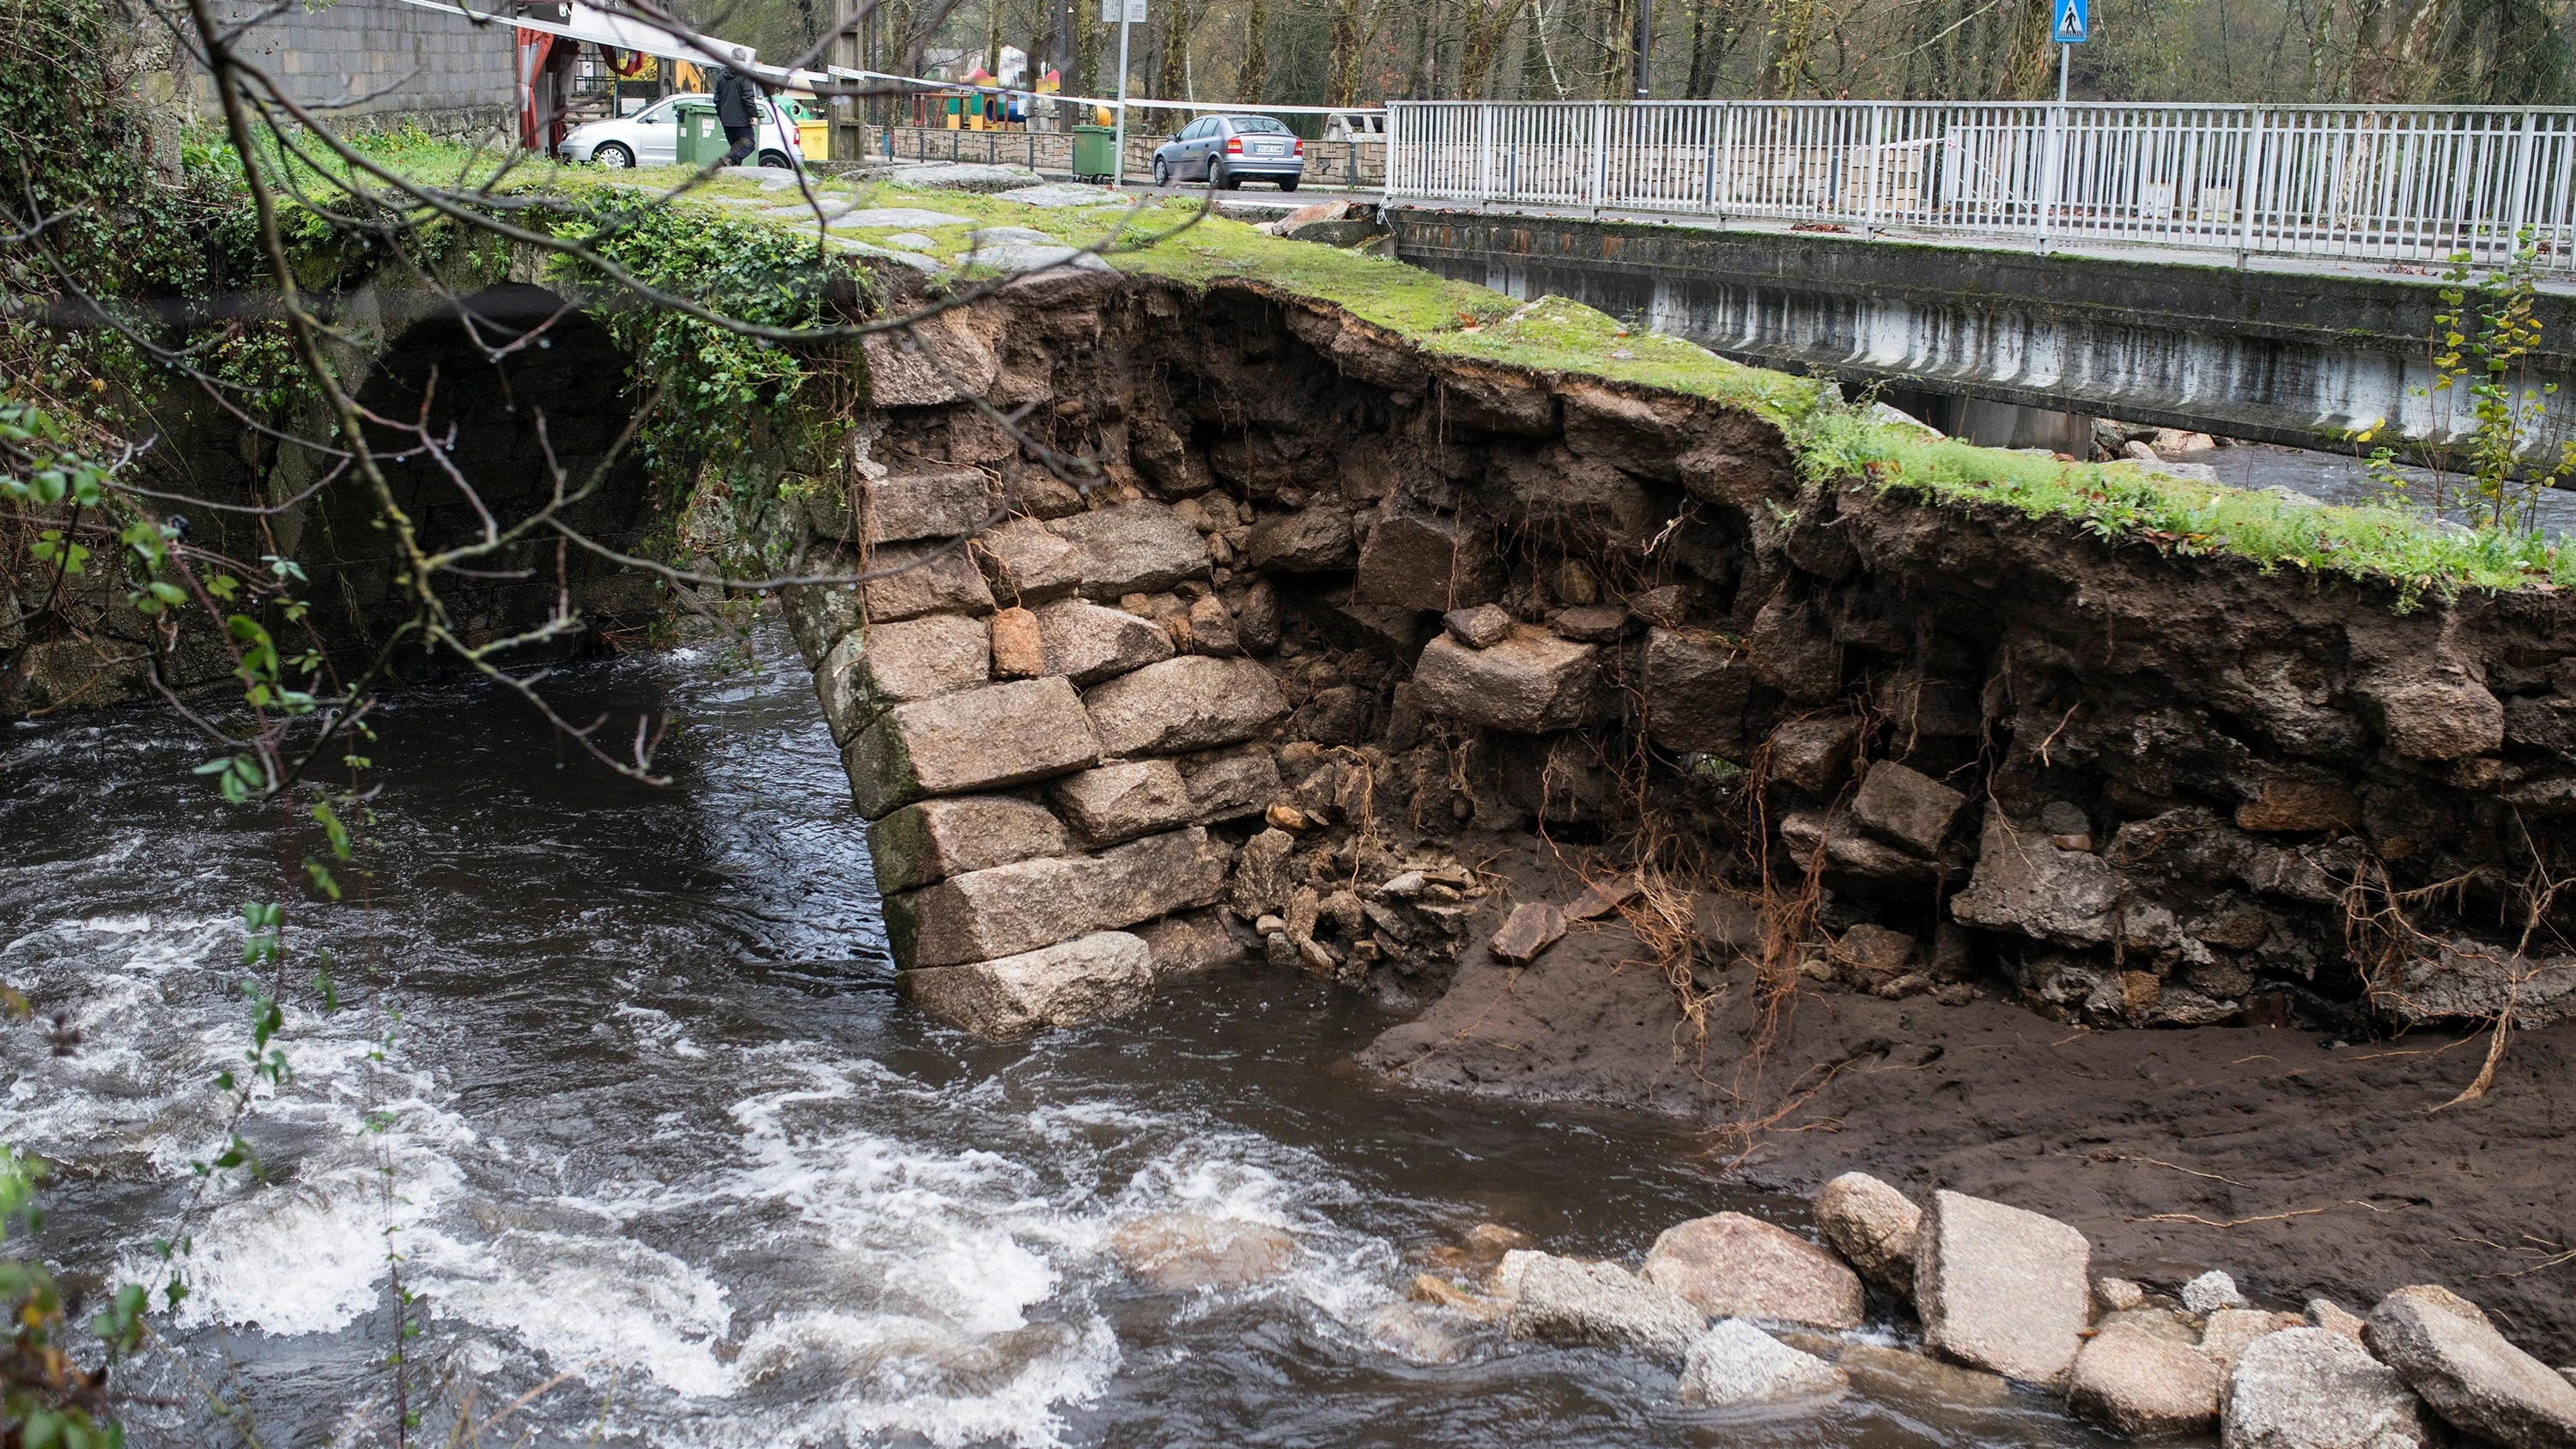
0 636 2092 1449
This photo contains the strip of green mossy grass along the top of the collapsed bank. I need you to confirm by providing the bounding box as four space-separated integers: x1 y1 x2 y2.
307 142 2576 608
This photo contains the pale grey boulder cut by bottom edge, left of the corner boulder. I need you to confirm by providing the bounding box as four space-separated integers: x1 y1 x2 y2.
2218 1328 2439 1449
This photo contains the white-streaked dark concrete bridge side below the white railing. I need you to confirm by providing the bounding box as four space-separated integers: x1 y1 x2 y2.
1388 209 2576 456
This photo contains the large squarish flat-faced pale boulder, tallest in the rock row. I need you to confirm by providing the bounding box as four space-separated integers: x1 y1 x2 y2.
1914 1191 2092 1385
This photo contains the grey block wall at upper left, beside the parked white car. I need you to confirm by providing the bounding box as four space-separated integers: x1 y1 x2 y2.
183 0 518 134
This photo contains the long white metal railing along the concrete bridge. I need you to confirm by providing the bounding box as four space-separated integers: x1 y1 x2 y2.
1386 100 2576 270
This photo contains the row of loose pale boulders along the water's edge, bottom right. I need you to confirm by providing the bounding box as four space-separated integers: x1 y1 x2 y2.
1414 1173 2576 1449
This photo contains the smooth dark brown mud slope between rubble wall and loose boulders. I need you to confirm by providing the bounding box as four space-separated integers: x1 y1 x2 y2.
1363 849 2576 1361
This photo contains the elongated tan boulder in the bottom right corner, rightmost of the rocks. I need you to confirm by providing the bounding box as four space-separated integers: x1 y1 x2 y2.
2362 1287 2576 1449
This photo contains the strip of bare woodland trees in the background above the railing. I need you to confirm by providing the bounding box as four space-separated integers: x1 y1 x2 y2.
683 0 2576 118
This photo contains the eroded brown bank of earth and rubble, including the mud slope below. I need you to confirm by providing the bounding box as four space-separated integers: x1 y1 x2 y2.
829 278 2576 1356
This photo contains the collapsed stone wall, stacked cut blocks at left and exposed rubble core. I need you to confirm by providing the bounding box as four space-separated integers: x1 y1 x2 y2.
788 273 2576 1029
